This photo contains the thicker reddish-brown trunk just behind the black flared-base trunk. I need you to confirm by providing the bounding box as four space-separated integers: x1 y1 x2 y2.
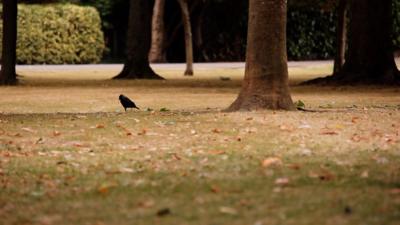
149 0 166 62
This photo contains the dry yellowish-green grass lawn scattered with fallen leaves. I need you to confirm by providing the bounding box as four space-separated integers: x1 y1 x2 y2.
0 63 400 225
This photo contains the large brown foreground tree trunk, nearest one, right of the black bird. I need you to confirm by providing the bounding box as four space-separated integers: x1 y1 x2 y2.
227 0 295 111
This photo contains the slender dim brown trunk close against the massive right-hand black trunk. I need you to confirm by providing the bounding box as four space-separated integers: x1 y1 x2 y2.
333 0 347 73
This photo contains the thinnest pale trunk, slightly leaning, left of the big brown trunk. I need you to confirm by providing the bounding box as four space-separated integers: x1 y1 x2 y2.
178 0 193 76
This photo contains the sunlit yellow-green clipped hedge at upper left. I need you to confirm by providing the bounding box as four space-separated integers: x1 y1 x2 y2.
0 4 105 64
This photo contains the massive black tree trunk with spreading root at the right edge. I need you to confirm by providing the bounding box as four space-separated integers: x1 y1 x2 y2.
305 0 400 85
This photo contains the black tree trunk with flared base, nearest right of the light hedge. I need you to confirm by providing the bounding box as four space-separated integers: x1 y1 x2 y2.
114 0 163 79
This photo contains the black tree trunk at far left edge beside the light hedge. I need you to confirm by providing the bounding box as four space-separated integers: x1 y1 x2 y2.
0 0 18 85
